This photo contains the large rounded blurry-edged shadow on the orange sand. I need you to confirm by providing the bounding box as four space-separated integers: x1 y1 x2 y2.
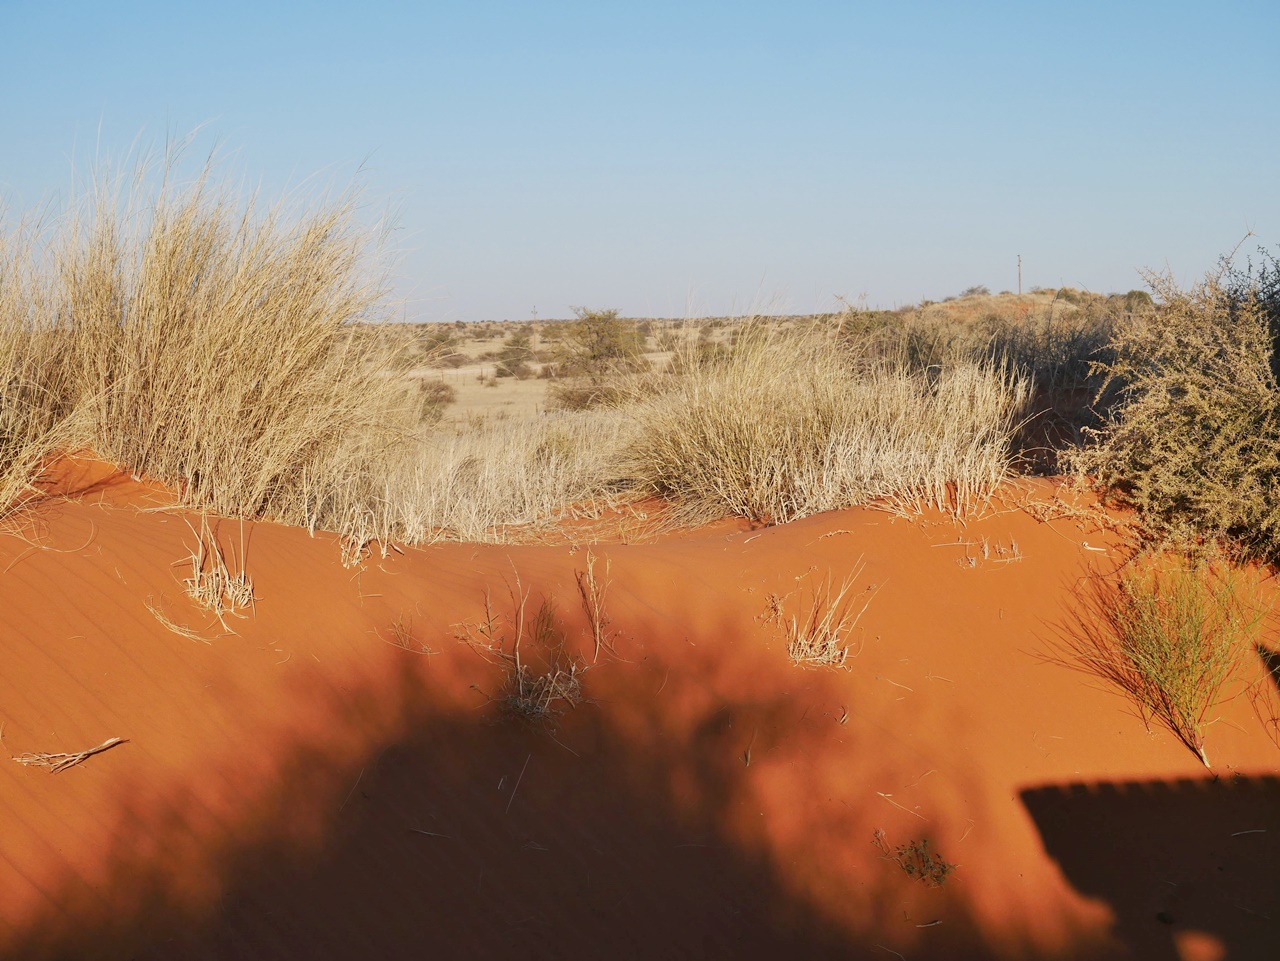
0 598 1208 961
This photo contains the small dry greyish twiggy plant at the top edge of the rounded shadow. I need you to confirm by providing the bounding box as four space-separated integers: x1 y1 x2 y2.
457 575 588 720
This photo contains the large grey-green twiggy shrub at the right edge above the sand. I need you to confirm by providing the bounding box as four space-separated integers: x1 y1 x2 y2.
1069 276 1280 557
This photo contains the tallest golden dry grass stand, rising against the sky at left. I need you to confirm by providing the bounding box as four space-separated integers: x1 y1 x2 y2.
0 157 415 542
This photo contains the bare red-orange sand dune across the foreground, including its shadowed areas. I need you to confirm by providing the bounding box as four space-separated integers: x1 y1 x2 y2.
0 462 1280 958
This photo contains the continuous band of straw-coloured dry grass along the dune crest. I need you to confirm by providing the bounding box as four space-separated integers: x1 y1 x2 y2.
0 159 1027 558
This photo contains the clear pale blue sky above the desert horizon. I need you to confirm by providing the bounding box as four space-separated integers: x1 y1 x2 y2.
0 0 1280 320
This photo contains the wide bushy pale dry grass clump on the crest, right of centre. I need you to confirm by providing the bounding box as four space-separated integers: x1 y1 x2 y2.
628 328 1028 523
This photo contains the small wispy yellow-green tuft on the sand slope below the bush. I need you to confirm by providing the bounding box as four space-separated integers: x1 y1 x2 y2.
1062 559 1265 768
